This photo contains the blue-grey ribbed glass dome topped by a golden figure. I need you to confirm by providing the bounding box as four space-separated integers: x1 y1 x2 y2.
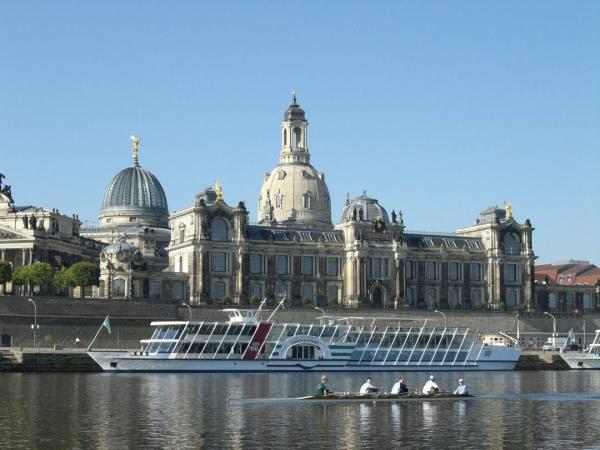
100 138 169 227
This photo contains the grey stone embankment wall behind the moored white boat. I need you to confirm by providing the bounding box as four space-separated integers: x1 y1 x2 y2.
0 296 600 349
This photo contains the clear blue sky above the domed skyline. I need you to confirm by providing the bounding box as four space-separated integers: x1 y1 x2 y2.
0 1 600 264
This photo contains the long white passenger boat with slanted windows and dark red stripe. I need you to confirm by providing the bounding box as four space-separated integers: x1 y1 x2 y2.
88 302 521 372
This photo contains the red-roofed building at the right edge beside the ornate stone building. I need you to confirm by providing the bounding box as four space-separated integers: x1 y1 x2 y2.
535 260 600 313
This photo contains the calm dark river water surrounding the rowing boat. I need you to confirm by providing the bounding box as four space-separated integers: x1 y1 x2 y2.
0 371 600 449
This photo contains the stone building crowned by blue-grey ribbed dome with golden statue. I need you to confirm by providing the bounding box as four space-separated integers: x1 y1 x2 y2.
81 136 187 300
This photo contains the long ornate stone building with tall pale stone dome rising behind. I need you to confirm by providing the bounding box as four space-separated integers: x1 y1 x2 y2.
167 96 534 308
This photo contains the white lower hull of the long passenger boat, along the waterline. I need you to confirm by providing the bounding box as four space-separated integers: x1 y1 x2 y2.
88 351 518 373
